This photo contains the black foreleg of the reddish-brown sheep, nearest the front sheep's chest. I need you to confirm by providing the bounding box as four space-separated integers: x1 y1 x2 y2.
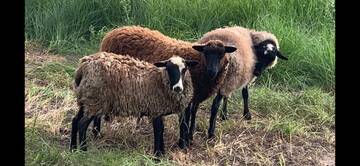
178 102 192 149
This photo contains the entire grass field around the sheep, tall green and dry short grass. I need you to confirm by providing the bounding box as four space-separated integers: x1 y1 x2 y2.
25 0 335 165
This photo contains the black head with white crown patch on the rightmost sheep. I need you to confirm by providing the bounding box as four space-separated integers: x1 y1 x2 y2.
254 39 288 77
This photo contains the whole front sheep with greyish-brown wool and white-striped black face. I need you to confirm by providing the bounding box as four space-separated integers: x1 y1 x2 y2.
70 52 198 156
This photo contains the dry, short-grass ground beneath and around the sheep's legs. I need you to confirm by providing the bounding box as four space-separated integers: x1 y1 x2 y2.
25 42 335 165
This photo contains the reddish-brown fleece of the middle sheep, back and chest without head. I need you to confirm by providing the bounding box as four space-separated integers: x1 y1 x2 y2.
100 26 228 102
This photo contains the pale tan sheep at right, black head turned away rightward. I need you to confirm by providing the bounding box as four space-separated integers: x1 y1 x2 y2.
195 27 285 138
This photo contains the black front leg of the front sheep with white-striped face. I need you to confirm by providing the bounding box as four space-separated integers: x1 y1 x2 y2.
153 116 165 157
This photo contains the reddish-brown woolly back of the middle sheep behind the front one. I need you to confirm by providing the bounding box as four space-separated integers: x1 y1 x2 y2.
100 26 201 63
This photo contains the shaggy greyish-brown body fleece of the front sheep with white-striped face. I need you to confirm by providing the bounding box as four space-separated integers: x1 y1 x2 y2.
74 52 193 118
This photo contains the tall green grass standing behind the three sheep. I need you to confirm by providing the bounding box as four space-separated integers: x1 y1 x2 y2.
25 0 335 91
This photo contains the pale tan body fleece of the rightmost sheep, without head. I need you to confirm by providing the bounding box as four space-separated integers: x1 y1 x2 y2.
198 27 256 97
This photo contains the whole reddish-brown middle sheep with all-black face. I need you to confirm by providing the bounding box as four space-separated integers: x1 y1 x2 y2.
100 26 236 148
